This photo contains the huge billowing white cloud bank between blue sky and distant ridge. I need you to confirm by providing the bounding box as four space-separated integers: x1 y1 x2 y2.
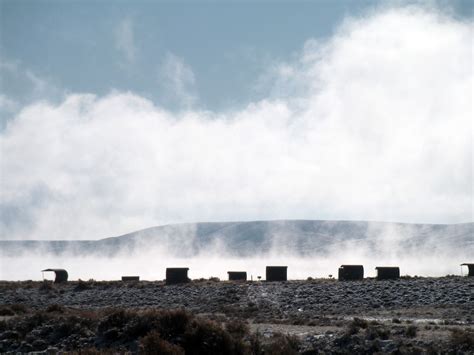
0 8 473 239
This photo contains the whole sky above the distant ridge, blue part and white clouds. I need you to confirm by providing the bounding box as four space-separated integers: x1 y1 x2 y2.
0 0 474 239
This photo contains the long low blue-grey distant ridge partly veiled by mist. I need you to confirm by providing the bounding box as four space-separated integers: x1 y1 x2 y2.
0 220 474 257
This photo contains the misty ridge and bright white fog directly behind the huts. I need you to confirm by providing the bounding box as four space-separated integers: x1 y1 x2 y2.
0 221 474 280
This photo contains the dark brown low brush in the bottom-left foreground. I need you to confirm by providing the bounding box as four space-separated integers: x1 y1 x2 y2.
0 305 304 355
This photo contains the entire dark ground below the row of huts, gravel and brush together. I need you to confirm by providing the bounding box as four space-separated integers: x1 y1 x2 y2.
0 276 474 354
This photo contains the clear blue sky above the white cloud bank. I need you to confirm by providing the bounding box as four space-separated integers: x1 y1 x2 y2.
0 0 472 118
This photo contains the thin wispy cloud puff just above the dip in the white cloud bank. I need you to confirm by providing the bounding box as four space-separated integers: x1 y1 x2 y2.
158 52 197 108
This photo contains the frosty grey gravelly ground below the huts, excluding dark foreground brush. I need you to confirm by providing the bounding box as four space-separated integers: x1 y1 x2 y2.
0 276 474 354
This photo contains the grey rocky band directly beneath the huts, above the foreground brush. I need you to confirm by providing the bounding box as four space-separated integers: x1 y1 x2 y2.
0 277 474 323
